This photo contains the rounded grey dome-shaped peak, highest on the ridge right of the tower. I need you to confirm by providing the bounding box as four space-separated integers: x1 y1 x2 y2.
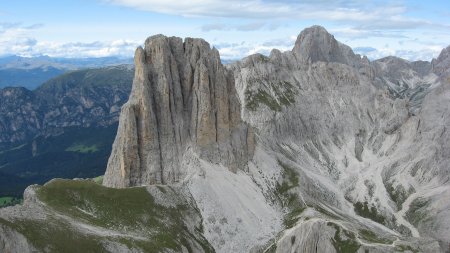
293 25 360 66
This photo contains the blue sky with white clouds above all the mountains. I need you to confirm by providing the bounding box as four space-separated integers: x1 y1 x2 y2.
0 0 450 61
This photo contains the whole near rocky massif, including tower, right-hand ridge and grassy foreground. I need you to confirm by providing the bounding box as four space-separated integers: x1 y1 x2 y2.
0 26 450 253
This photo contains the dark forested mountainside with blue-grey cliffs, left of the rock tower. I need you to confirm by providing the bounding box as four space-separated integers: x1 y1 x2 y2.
0 65 134 197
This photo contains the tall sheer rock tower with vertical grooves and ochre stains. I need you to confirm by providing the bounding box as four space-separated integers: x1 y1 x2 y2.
104 35 254 187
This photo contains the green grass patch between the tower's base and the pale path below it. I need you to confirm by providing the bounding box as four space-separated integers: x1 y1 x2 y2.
33 179 213 252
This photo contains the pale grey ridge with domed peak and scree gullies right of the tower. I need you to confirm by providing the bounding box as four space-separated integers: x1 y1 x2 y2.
230 27 450 252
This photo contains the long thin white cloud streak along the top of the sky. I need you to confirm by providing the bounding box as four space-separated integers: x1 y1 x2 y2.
100 0 438 29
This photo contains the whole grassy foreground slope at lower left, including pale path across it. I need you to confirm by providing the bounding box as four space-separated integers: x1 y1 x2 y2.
0 179 214 252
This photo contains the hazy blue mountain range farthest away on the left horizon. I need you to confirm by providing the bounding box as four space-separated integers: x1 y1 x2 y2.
0 55 133 90
